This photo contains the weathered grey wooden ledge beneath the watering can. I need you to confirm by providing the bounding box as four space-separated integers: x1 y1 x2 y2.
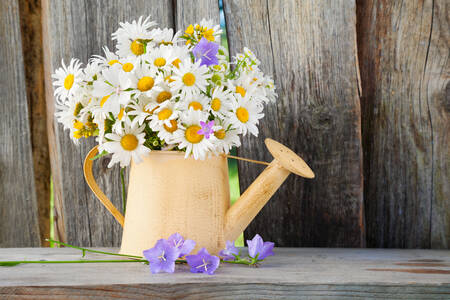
0 248 450 299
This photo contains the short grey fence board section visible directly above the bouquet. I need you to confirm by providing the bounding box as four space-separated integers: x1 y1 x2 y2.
174 0 220 31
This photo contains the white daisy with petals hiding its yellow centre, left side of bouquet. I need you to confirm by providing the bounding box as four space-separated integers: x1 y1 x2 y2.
92 67 131 116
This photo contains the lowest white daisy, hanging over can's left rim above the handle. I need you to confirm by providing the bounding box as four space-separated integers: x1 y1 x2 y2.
102 122 150 168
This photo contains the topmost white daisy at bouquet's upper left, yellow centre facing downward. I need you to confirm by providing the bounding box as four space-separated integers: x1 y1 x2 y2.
112 17 156 57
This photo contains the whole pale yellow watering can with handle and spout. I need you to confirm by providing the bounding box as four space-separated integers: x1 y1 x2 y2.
84 139 314 256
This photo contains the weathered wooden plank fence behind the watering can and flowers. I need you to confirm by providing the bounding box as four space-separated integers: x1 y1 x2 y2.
0 0 450 248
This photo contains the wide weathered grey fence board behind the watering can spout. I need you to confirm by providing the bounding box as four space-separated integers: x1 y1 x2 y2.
224 0 365 247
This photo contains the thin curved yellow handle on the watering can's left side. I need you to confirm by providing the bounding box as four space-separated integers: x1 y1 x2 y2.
83 146 125 227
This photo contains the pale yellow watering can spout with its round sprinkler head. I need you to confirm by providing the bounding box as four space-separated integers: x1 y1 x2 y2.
224 139 314 241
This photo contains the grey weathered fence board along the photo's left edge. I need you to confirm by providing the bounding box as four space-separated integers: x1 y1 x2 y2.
0 0 40 247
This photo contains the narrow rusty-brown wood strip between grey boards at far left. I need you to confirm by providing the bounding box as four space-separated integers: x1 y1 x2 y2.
19 0 50 246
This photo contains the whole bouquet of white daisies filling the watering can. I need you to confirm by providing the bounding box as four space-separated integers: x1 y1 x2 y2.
52 17 277 167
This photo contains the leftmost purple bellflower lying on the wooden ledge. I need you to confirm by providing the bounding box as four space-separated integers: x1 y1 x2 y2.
143 239 179 274
